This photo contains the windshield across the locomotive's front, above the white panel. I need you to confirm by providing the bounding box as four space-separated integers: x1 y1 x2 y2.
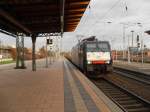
86 42 110 52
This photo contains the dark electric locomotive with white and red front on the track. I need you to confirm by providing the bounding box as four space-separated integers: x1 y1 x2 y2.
71 36 112 75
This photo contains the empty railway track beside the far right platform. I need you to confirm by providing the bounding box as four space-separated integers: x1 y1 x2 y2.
114 67 150 85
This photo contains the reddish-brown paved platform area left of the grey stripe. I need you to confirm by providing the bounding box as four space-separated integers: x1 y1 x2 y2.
0 61 64 112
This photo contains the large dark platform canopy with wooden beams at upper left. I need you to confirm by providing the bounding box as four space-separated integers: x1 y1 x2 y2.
0 0 90 34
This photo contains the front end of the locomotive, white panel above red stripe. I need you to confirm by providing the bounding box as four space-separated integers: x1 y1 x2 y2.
86 41 112 72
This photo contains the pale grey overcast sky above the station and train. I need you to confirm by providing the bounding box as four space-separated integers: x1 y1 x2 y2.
0 0 150 51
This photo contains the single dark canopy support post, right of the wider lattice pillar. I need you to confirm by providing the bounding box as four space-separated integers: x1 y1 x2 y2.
32 35 36 71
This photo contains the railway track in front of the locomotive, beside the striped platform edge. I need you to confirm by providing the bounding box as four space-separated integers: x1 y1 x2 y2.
92 78 150 112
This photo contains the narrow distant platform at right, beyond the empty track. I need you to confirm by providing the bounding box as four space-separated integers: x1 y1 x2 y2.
113 60 150 75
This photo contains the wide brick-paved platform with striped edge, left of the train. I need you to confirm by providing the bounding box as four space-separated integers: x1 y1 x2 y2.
0 59 122 112
